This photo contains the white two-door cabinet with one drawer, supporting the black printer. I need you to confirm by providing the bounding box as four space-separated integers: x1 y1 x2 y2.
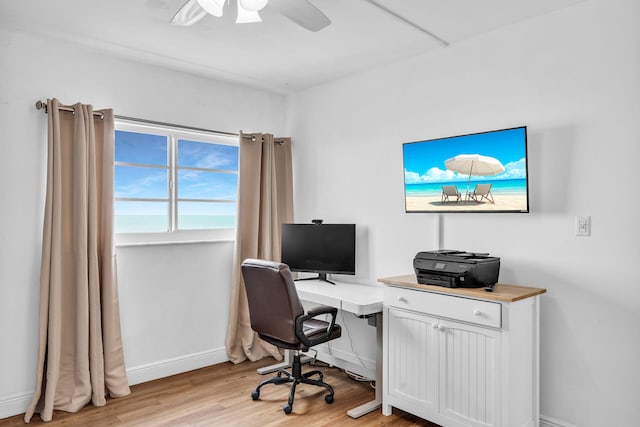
383 280 539 427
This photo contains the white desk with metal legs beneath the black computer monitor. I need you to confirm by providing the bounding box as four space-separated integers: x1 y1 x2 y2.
259 280 384 418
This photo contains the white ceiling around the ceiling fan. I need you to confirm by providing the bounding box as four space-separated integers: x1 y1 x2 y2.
0 0 584 93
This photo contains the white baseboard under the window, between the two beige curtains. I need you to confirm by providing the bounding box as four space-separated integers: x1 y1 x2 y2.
127 347 229 385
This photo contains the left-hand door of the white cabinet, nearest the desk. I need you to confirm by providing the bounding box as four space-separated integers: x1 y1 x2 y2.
386 308 439 417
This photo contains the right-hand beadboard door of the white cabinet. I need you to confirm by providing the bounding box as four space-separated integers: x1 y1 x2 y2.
437 320 500 427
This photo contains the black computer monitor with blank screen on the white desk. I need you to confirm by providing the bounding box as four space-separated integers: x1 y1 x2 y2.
281 224 356 280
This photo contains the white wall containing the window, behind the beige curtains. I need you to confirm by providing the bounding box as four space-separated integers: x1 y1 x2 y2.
0 29 286 418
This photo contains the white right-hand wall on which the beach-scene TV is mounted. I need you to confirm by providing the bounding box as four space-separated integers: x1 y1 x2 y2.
287 0 640 427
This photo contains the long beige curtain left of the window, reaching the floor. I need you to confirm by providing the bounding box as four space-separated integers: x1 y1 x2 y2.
24 99 129 422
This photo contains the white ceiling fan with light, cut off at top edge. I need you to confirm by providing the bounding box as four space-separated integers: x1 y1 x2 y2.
171 0 331 31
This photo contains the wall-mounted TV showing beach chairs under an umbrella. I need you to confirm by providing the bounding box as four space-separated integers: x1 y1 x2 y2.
402 126 529 212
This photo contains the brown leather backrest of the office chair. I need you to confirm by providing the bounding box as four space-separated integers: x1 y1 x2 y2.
241 259 304 344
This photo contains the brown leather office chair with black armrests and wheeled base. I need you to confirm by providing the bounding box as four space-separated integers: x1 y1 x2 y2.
241 259 342 414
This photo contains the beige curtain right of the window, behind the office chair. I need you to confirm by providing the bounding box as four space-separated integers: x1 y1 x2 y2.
226 132 293 363
